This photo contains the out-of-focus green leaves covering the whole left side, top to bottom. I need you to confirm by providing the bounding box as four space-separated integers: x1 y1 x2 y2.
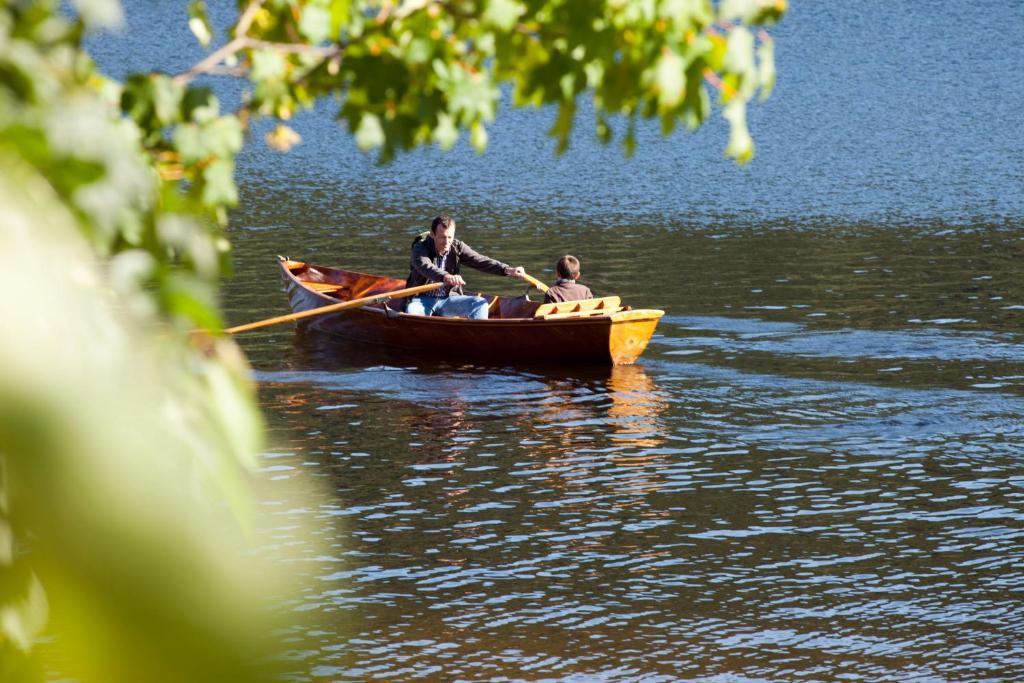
0 0 315 682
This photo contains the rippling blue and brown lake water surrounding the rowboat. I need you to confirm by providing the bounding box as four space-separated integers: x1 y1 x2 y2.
88 2 1024 682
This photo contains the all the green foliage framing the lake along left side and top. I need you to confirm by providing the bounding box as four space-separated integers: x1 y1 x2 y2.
0 0 785 681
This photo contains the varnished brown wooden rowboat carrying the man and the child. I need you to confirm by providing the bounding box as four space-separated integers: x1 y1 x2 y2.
279 257 665 365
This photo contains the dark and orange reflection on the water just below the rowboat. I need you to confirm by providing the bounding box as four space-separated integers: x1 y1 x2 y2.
291 329 669 455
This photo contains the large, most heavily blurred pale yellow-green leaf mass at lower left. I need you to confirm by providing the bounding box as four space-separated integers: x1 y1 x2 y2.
0 155 296 681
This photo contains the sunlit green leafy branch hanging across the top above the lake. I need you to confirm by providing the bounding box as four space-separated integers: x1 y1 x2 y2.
184 0 786 163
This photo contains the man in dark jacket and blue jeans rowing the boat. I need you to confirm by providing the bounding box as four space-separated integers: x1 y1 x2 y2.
406 214 526 321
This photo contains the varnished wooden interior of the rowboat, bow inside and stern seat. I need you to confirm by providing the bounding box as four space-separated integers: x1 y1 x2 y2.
284 260 629 319
